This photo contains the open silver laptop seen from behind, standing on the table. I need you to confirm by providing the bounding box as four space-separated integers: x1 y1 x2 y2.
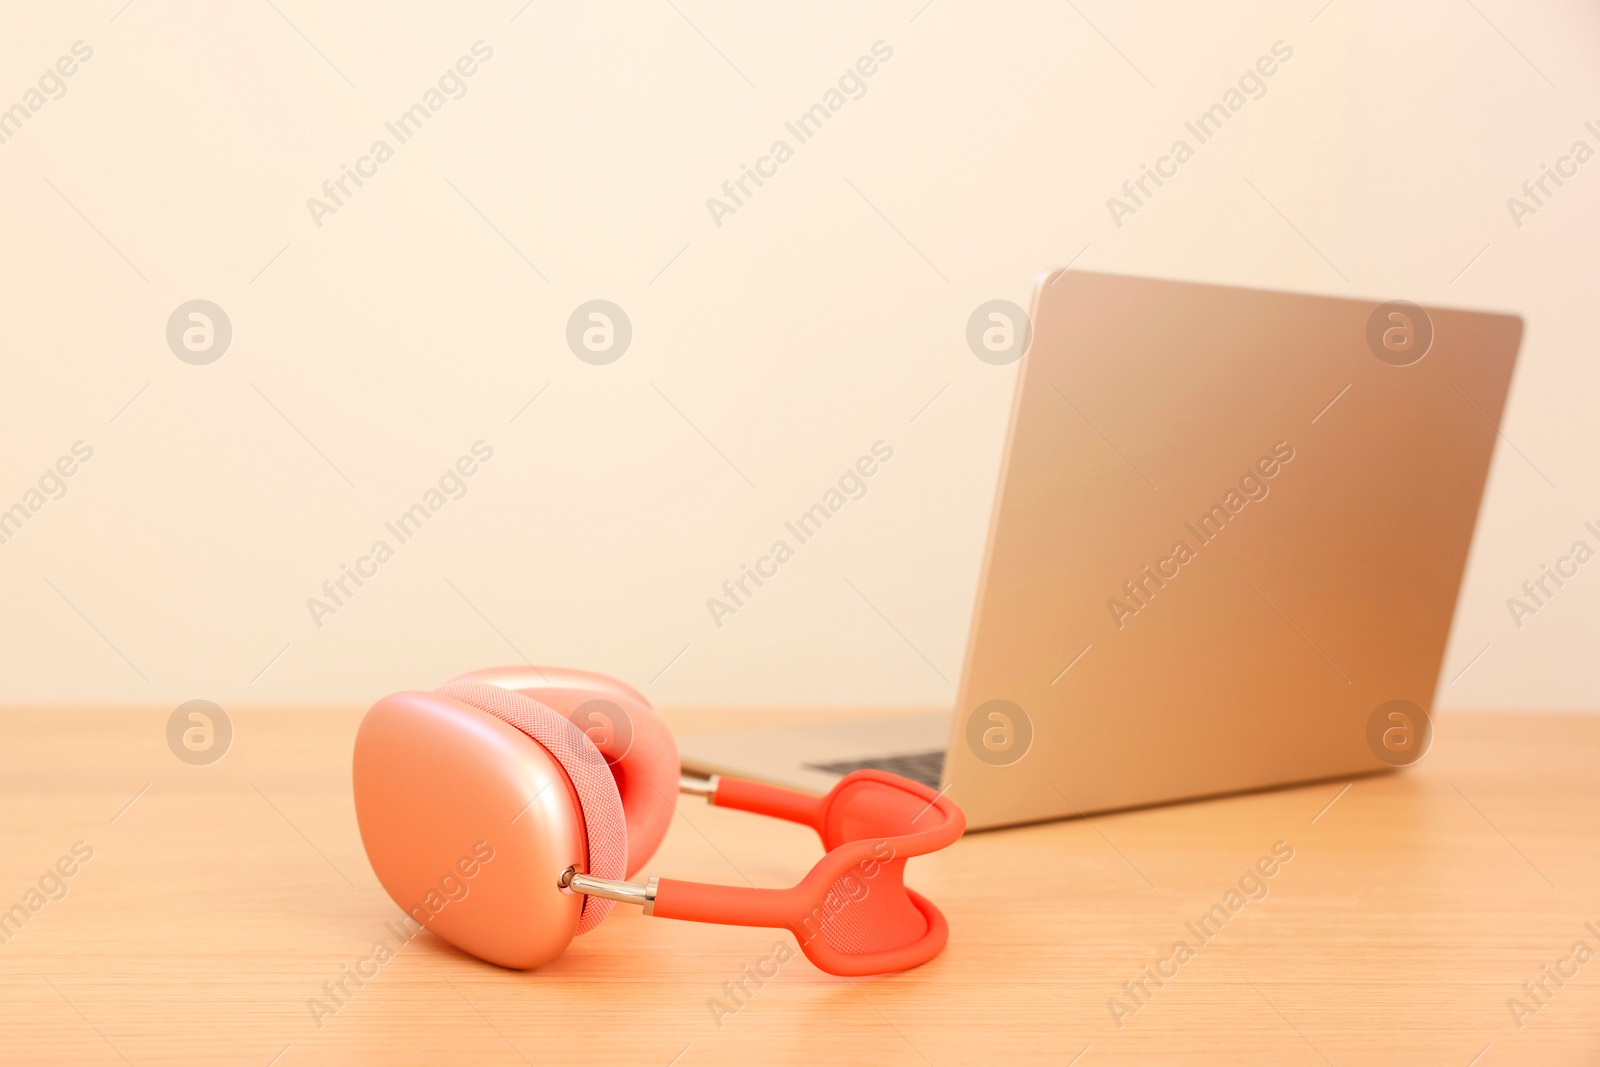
680 270 1522 829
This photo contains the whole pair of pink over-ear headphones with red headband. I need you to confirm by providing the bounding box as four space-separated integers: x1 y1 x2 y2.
352 665 966 976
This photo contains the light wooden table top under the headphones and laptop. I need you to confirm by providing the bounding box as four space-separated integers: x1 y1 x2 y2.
0 707 1600 1067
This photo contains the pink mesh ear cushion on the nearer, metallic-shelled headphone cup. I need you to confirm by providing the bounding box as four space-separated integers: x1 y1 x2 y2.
434 681 627 934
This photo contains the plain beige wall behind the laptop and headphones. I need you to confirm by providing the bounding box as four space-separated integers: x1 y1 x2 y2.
0 0 1600 709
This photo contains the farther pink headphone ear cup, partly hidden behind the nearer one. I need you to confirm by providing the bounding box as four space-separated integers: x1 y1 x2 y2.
444 667 682 878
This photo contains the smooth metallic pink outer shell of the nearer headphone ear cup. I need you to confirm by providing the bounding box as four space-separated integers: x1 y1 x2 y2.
352 693 589 968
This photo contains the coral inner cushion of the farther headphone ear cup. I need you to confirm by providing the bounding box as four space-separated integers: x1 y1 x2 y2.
505 686 680 878
